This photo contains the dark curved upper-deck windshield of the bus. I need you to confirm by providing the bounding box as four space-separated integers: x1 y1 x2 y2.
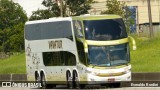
83 18 127 41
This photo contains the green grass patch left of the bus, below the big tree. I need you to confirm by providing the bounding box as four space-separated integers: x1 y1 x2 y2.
0 53 26 74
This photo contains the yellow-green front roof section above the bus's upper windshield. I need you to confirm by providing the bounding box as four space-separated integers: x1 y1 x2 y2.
72 14 122 20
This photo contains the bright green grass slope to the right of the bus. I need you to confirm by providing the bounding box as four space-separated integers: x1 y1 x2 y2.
130 34 160 72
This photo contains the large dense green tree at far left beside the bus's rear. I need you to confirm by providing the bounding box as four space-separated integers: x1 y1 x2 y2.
0 0 27 52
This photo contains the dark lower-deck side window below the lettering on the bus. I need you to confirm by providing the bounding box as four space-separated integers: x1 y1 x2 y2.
43 51 76 66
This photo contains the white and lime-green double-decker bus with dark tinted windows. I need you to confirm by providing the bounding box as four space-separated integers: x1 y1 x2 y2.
25 15 135 88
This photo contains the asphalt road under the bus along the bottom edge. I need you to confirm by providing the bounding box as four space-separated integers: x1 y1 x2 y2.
0 82 160 90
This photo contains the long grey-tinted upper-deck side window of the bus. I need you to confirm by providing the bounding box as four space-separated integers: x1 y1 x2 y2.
25 21 72 40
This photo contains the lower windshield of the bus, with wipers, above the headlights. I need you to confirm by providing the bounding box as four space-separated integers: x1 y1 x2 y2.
88 43 130 66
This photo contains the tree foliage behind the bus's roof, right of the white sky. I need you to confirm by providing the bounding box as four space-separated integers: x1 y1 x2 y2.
29 0 93 20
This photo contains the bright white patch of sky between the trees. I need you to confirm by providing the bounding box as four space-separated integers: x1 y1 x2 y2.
13 0 45 17
